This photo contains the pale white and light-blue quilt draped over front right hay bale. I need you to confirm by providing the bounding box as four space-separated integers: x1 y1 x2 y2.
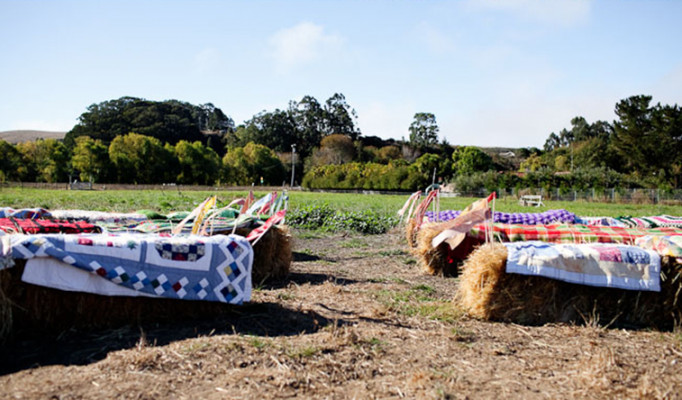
505 241 661 292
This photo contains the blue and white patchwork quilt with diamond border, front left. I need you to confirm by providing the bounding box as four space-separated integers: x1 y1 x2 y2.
8 234 253 304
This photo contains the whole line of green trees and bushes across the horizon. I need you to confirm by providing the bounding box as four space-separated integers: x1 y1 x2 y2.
0 93 682 191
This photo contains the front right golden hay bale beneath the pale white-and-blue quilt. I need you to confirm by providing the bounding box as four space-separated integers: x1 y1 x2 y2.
454 243 682 330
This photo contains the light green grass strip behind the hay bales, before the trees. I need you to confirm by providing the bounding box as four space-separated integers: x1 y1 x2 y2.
0 188 682 217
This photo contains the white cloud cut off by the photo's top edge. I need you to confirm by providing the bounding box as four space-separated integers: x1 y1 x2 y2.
466 0 591 26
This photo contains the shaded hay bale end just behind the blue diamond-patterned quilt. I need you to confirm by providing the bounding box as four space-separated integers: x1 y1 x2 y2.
236 226 293 285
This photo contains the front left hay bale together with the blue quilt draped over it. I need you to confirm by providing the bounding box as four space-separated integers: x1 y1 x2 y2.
0 234 254 339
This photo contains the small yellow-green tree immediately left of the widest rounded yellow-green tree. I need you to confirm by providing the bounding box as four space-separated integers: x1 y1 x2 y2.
71 136 109 182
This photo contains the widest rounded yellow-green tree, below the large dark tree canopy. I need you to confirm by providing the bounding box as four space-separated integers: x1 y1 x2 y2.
109 132 178 183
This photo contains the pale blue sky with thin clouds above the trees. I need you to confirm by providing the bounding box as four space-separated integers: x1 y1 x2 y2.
0 0 682 147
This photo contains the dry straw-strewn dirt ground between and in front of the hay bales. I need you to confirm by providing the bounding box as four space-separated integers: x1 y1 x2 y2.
0 232 682 399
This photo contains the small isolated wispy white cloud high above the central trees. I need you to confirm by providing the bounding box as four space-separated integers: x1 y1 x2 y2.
269 22 343 73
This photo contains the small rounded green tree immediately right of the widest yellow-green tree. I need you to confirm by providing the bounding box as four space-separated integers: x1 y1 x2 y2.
174 140 221 185
